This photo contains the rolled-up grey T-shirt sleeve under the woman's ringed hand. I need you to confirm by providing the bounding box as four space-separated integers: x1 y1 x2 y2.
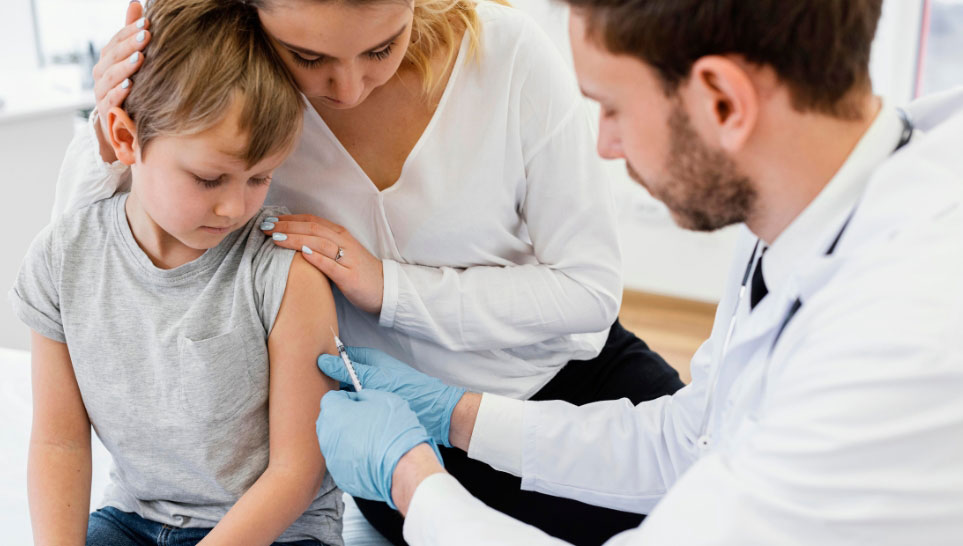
251 207 294 336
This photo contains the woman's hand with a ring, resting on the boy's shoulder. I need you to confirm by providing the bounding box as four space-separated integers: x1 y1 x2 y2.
261 214 385 314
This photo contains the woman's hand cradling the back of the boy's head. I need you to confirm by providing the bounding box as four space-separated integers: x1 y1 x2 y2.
93 2 150 163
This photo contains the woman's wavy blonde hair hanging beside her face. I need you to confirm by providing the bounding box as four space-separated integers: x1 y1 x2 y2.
242 0 509 95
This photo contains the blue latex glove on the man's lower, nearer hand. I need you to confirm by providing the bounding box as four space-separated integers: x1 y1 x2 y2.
315 390 444 510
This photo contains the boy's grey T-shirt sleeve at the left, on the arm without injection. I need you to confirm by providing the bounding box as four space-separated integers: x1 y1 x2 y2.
9 223 67 343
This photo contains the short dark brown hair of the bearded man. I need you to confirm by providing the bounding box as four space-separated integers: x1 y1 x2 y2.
564 0 882 119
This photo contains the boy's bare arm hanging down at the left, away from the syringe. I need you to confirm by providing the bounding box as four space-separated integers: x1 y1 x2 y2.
27 332 91 545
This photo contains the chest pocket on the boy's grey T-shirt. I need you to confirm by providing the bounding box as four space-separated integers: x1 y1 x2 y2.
178 327 259 422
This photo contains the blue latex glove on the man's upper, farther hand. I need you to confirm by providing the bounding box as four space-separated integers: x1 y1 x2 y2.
318 347 465 447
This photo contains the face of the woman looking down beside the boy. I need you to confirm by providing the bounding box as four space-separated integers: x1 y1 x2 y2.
258 0 414 109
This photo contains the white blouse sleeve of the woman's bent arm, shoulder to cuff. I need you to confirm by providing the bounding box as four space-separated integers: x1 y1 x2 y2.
379 23 622 351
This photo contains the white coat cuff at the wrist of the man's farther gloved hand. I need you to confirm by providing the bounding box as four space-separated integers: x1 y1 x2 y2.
468 393 525 476
